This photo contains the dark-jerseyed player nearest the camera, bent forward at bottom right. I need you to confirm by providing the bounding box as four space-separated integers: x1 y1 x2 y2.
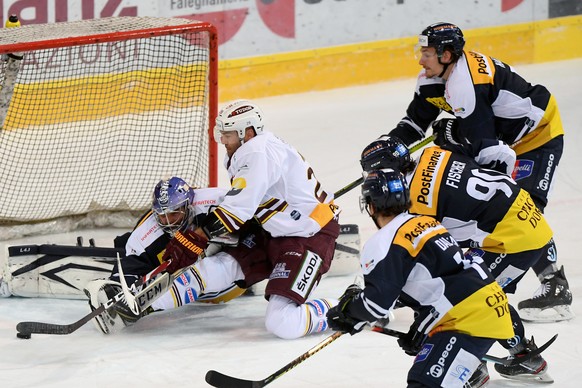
328 169 514 387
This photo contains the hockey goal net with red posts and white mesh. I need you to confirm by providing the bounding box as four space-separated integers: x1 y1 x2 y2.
0 17 218 240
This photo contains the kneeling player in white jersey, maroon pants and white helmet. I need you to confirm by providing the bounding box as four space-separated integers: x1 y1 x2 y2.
169 100 339 339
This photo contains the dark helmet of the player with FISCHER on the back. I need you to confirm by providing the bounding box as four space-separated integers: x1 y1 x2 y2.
360 136 414 173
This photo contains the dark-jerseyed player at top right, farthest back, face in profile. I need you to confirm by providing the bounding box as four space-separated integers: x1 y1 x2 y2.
389 23 574 321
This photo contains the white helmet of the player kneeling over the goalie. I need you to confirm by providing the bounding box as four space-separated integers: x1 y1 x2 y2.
214 100 264 143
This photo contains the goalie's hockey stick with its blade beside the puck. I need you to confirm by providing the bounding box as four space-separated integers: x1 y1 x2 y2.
16 260 171 338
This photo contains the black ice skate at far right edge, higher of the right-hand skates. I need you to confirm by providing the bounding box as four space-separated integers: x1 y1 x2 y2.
517 266 575 322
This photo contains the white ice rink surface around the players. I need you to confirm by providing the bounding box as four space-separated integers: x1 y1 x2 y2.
0 59 582 388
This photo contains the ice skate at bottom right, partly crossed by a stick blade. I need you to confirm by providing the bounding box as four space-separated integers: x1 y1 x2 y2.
495 337 554 384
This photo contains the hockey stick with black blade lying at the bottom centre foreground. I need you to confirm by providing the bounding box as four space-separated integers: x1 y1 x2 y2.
205 331 344 388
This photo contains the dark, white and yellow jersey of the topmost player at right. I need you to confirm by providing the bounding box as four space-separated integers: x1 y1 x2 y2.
389 51 564 155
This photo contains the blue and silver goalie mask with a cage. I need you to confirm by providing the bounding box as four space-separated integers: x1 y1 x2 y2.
152 177 194 237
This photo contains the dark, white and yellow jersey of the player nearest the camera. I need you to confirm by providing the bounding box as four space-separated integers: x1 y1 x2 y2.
348 213 513 339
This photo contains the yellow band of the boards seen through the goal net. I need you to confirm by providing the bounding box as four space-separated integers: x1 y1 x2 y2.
4 63 208 129
